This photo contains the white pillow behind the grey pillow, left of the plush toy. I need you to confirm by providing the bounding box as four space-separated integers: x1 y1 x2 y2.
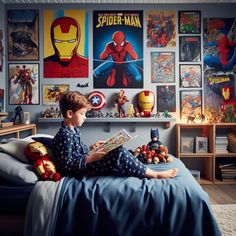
0 139 32 163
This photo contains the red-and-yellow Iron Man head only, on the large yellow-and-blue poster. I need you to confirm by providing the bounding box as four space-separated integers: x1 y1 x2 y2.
51 17 80 62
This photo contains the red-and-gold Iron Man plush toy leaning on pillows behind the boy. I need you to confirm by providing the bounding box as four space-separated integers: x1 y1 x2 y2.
24 142 61 181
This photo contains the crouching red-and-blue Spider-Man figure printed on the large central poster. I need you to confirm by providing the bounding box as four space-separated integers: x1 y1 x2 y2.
94 31 142 87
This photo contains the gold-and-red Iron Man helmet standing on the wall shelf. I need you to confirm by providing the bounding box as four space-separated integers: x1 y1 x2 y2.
138 90 155 117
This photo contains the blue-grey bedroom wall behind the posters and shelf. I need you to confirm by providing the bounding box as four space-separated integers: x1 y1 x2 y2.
0 4 236 154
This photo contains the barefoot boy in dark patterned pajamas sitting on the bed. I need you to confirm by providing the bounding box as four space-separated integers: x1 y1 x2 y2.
53 92 178 178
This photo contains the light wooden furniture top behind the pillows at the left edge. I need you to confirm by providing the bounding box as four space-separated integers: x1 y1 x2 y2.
0 124 36 138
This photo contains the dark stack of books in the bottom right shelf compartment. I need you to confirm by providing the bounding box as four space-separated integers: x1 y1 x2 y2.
216 163 236 182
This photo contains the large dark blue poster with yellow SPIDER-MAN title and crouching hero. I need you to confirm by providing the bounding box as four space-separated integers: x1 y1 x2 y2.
93 11 143 88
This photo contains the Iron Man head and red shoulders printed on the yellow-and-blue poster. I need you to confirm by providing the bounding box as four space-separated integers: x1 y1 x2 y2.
44 17 88 78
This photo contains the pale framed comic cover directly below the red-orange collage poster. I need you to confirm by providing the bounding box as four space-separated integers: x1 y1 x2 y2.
151 52 175 83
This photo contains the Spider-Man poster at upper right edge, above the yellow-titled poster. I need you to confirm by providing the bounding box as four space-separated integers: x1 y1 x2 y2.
203 18 236 71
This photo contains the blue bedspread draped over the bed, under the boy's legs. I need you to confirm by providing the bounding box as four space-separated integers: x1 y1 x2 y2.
51 158 221 236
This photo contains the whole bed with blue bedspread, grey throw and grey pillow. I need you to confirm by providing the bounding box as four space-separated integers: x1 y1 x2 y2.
0 135 221 236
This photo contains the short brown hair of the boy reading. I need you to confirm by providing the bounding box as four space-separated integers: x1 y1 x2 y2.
59 91 92 117
